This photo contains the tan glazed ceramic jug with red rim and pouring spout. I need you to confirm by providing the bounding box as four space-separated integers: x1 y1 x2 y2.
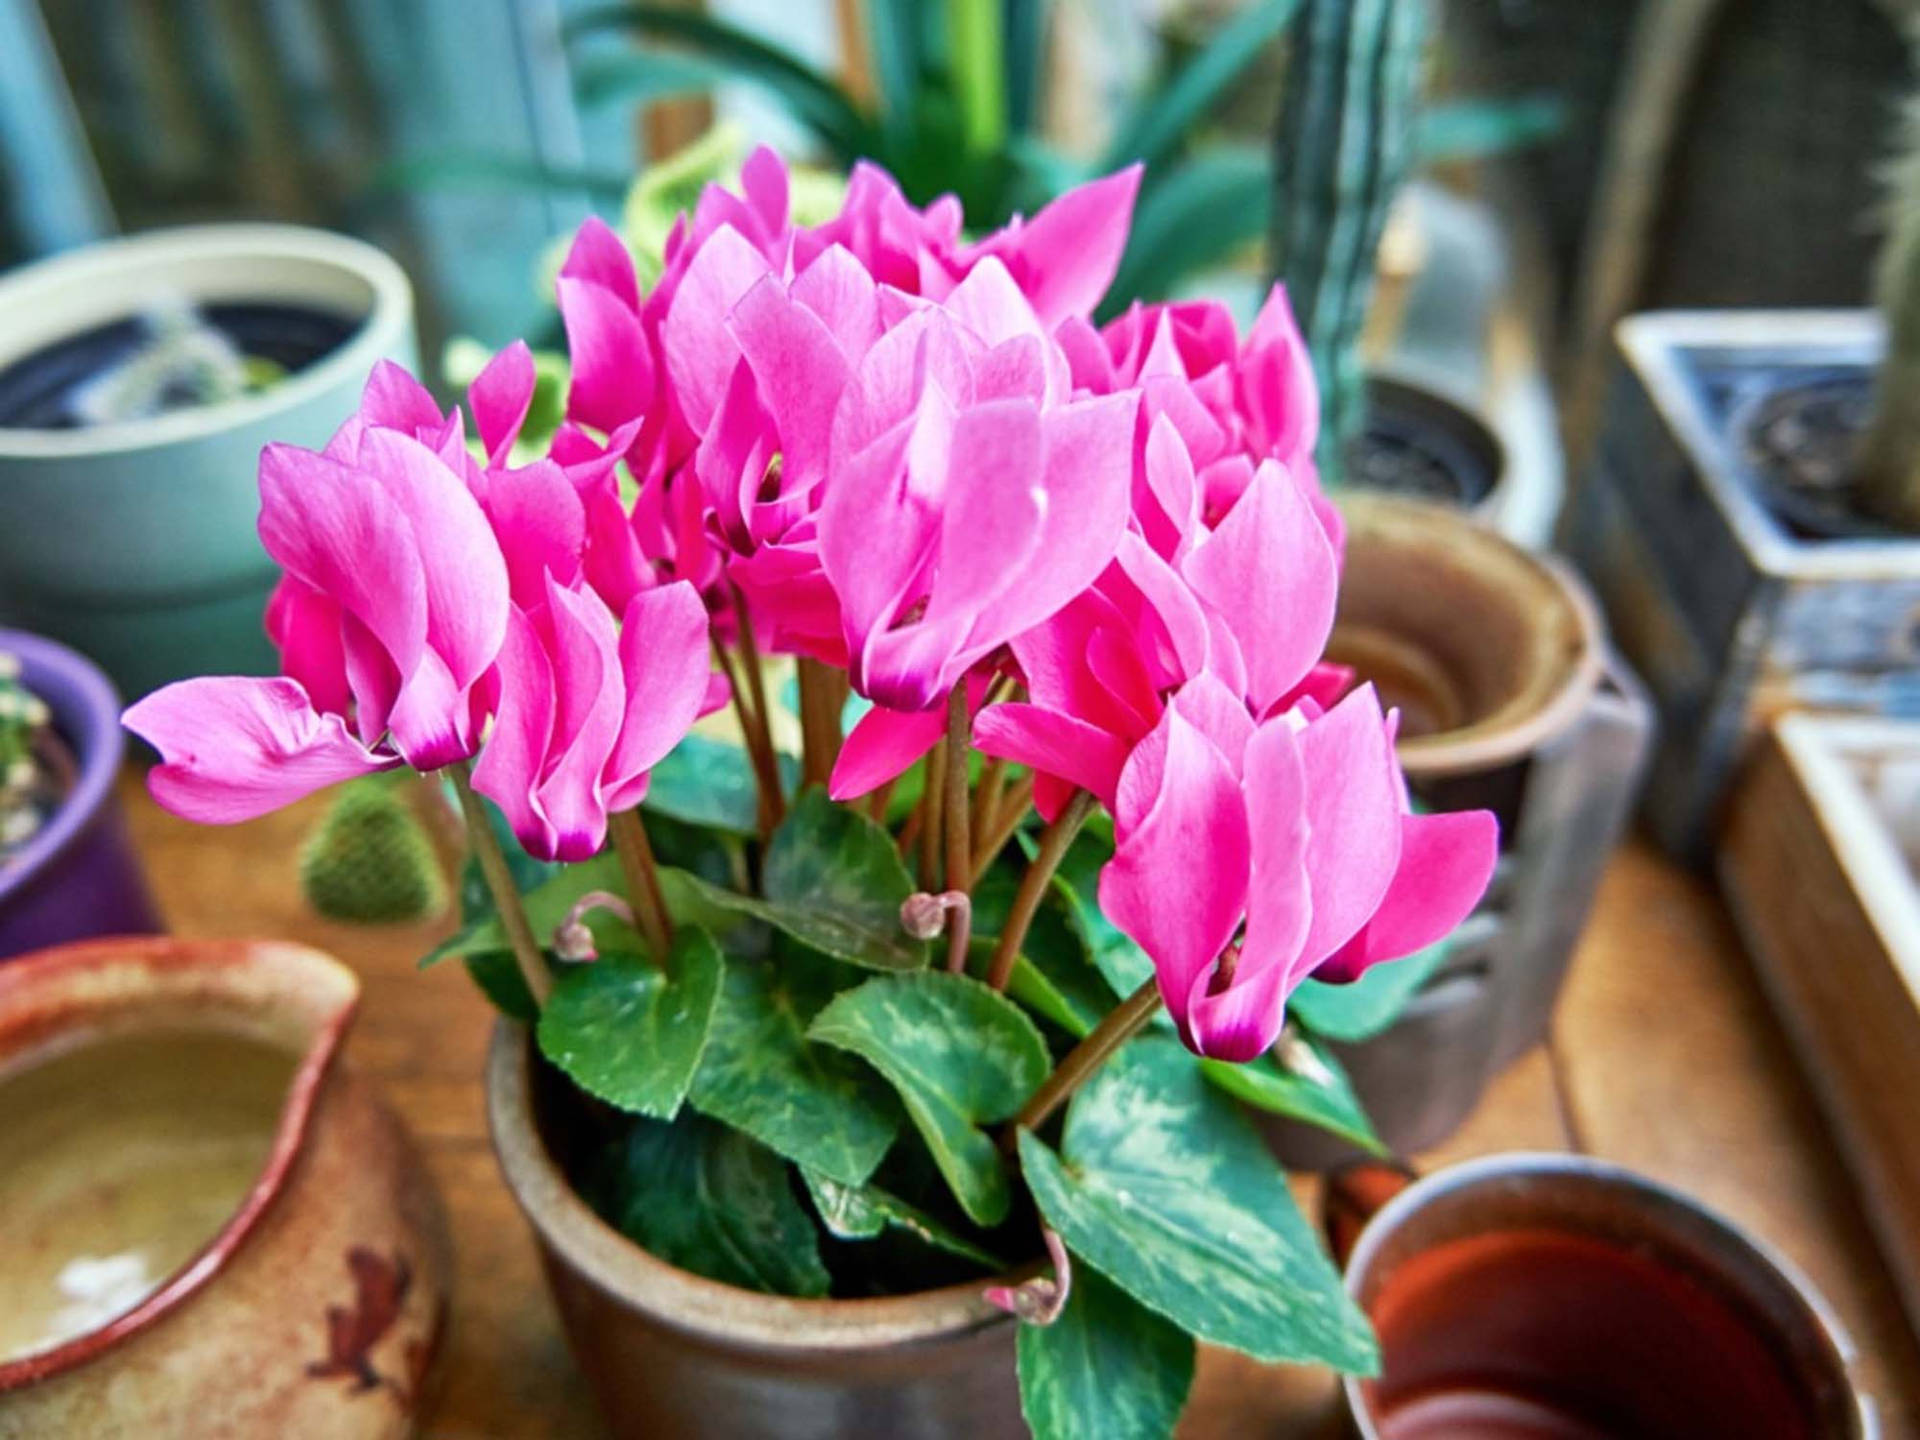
0 939 451 1440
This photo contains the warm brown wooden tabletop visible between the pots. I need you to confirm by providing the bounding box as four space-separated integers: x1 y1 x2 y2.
125 776 1920 1440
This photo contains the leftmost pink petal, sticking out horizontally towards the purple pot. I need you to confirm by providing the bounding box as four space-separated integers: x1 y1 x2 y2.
121 676 397 826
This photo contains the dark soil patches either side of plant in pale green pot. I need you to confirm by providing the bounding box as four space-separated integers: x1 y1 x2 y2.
0 301 363 430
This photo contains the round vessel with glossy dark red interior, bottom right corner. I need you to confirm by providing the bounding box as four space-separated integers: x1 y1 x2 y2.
1327 1154 1880 1440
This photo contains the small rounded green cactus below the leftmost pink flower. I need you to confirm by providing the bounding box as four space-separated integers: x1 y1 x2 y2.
300 778 447 925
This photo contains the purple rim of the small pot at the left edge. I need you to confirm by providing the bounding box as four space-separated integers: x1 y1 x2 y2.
0 628 127 902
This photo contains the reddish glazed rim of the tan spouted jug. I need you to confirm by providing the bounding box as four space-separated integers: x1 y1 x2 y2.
0 935 359 1396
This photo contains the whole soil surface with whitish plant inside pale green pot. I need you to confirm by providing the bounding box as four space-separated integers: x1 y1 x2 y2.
0 301 363 430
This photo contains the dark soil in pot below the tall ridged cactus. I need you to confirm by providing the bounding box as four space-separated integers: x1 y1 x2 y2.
1342 376 1500 511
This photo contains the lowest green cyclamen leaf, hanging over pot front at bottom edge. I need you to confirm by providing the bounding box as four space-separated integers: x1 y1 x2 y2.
1018 1265 1194 1440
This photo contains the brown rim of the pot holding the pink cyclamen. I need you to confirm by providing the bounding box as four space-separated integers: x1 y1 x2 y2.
486 1018 1021 1356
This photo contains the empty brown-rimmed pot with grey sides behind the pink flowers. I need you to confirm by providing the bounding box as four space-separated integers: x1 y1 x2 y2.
1281 493 1651 1167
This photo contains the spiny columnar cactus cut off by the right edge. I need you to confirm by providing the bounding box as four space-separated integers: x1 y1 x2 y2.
1859 96 1920 530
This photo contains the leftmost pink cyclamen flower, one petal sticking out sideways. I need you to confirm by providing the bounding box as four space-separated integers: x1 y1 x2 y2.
125 367 511 822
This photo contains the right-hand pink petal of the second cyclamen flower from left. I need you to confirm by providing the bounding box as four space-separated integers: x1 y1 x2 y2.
603 580 726 810
